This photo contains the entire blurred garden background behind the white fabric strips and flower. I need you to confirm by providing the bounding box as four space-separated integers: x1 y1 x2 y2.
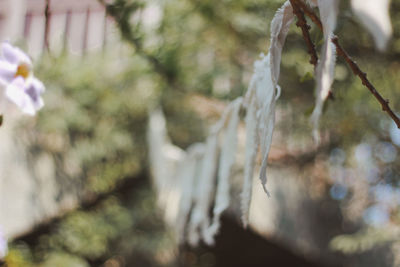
0 0 400 267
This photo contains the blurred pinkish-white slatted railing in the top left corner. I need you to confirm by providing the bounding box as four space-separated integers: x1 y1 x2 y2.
0 0 118 58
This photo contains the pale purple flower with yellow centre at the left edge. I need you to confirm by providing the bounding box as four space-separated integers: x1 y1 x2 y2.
0 42 45 115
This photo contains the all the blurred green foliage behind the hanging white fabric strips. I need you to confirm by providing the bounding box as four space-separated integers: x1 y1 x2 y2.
2 0 400 266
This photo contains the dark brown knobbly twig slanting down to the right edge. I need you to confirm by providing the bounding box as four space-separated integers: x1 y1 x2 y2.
290 0 400 129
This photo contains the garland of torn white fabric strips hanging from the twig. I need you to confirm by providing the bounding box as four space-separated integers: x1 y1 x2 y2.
148 0 391 245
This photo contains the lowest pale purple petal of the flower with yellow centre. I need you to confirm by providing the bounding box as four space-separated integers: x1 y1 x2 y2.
6 77 36 115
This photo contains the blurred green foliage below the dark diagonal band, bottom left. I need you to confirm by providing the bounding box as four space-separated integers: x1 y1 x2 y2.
6 184 173 267
